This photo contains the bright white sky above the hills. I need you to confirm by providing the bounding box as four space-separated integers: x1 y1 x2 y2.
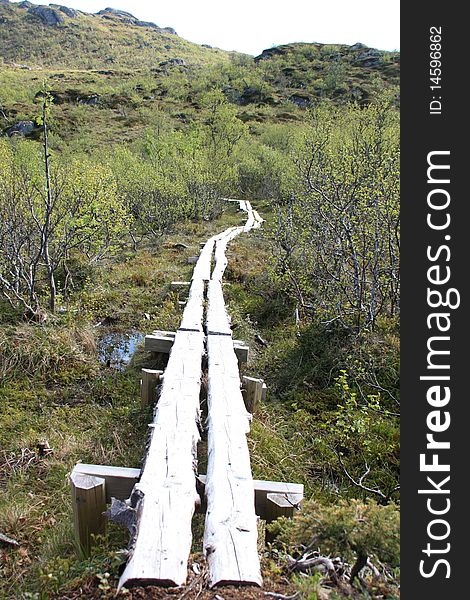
11 0 400 55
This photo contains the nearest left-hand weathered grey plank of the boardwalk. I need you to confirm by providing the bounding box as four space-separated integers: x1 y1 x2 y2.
119 330 204 587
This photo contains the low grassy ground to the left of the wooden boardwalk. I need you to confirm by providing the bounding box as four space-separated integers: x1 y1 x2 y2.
0 207 246 599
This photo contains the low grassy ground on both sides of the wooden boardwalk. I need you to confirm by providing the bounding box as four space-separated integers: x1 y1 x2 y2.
0 201 398 600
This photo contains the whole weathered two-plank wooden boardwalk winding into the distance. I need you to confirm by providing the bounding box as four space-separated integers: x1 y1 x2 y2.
119 201 262 587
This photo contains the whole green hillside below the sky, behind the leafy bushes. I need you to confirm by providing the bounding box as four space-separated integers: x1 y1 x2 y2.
0 0 400 149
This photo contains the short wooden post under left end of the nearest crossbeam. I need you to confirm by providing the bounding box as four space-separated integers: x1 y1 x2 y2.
70 471 106 555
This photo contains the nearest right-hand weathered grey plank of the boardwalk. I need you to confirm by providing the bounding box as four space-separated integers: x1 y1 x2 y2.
204 335 262 587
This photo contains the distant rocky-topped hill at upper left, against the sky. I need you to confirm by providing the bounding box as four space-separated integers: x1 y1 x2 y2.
0 0 227 69
